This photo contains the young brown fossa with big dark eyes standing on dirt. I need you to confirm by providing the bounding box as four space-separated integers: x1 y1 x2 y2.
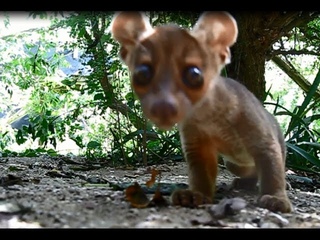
111 12 292 212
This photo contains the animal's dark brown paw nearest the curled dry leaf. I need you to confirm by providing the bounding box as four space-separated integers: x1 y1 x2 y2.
171 190 212 208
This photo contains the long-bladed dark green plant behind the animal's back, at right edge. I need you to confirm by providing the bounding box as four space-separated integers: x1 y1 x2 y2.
265 71 320 172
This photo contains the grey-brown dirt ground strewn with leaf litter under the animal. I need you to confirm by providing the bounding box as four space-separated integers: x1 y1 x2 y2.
0 157 320 228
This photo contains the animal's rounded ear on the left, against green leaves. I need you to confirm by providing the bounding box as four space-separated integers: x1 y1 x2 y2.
110 12 154 62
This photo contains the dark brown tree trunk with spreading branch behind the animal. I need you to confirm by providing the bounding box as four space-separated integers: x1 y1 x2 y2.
226 11 318 101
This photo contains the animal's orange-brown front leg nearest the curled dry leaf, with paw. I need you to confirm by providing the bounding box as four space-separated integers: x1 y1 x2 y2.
171 141 218 207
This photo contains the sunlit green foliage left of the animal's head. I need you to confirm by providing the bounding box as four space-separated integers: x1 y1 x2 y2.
3 12 187 164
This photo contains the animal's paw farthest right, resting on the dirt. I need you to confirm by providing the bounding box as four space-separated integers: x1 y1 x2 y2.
258 195 292 213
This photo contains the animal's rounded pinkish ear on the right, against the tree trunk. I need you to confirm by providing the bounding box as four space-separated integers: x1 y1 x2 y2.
191 12 238 64
